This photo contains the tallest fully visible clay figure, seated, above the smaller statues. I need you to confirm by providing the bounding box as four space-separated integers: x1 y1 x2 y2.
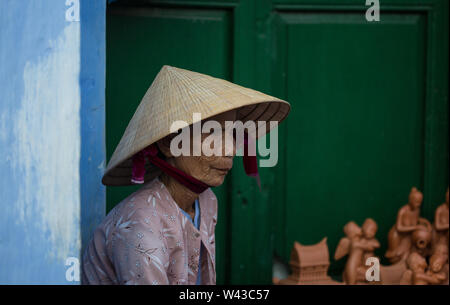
385 187 428 264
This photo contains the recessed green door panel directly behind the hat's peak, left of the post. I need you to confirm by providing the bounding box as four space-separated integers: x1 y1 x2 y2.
106 6 232 283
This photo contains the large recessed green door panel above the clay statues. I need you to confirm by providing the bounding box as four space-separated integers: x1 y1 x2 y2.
276 8 448 275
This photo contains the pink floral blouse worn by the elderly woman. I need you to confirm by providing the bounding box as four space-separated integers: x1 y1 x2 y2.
82 178 217 285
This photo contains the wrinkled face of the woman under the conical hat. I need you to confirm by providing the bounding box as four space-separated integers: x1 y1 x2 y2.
163 110 236 186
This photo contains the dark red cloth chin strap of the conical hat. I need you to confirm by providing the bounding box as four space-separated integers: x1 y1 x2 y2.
131 134 261 194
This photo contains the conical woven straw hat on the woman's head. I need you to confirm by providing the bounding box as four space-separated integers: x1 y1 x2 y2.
102 65 290 186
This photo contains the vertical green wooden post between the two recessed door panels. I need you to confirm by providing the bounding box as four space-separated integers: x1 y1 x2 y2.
229 0 276 284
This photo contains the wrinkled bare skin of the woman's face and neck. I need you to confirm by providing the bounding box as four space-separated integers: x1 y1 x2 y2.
157 110 236 216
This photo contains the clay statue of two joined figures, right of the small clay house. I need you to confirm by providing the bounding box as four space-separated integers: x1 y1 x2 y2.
334 220 379 285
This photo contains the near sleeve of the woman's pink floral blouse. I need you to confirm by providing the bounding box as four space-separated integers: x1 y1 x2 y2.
111 209 169 285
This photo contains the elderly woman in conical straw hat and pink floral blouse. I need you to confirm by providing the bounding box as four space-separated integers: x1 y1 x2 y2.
82 66 290 284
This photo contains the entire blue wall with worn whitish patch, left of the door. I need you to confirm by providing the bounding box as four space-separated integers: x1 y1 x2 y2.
0 0 106 284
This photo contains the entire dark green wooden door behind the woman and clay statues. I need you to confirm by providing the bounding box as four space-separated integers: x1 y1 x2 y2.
106 0 448 284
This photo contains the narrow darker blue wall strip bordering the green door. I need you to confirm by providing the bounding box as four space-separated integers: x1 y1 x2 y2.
80 0 106 262
